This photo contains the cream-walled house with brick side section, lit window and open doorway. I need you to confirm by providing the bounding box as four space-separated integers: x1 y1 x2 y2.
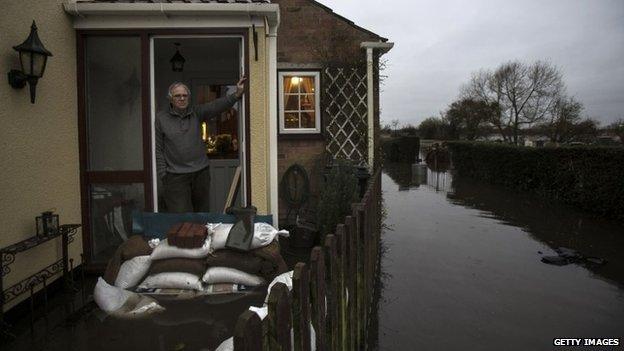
0 0 392 312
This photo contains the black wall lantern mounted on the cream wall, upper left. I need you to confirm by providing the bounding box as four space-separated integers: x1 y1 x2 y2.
9 21 52 104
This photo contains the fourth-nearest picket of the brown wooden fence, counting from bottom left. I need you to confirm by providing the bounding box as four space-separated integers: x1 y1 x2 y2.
310 246 328 351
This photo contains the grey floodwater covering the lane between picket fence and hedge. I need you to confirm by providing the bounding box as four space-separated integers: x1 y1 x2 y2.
376 164 624 350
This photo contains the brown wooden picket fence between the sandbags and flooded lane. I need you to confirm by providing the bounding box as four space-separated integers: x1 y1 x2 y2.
234 170 381 351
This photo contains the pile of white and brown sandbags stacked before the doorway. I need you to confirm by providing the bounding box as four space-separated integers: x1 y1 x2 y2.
94 223 288 312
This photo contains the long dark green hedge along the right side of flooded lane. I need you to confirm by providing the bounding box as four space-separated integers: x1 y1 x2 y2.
448 142 624 220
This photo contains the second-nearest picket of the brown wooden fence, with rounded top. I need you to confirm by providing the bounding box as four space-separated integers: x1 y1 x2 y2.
267 283 291 351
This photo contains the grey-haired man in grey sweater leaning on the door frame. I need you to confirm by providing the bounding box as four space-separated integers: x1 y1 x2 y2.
155 78 246 212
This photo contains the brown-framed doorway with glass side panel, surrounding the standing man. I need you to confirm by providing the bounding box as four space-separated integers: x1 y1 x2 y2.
77 29 250 269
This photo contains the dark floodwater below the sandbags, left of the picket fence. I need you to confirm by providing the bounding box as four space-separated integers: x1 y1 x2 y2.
0 283 266 351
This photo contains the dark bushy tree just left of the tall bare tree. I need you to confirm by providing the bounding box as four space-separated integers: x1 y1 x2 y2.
445 98 499 140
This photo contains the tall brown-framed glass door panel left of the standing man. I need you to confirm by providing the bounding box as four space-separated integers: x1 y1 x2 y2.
78 32 151 266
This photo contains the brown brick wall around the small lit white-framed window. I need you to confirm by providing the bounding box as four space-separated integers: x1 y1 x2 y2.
272 0 381 225
